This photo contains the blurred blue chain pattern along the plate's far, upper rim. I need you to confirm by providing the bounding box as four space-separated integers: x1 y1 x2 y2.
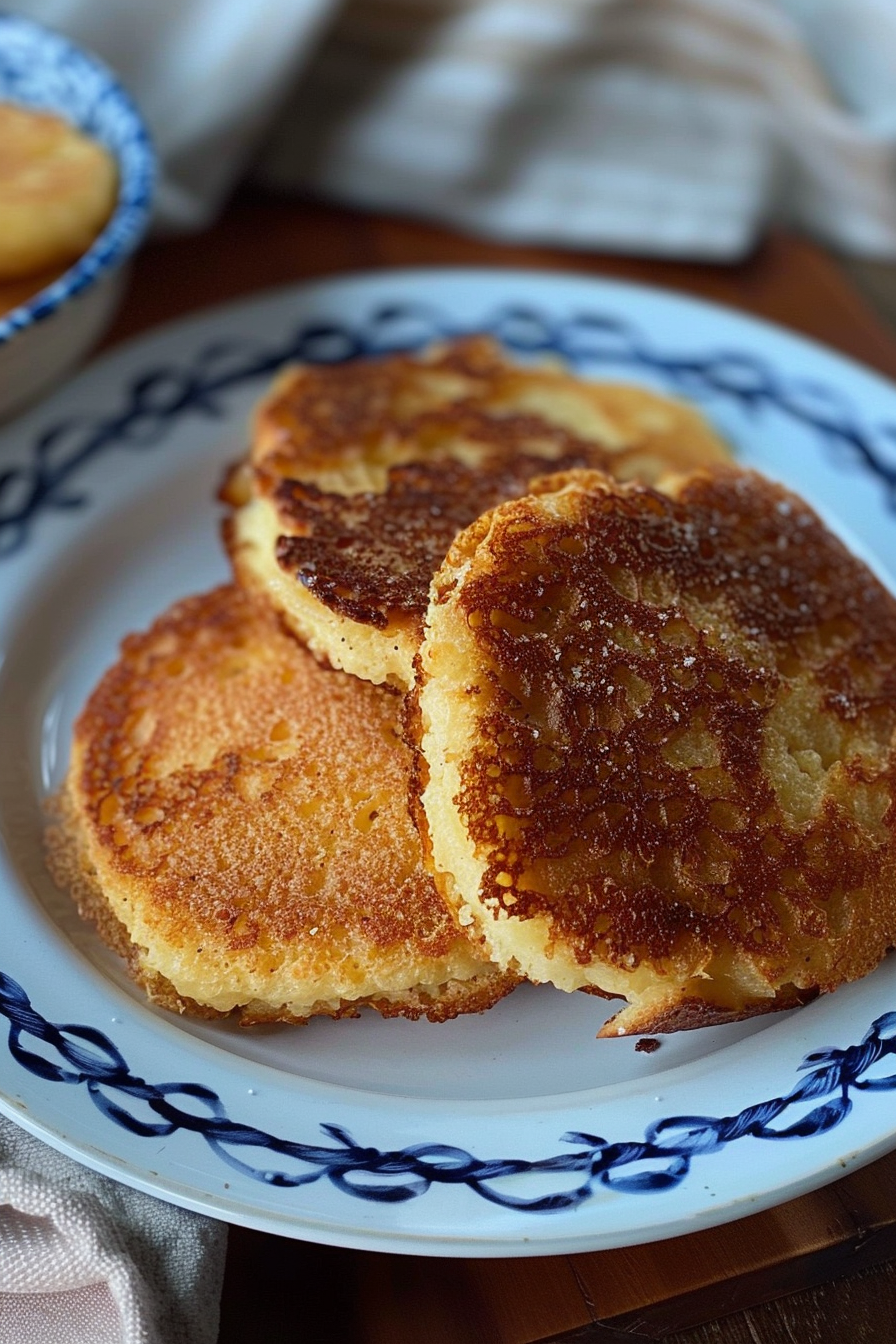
0 302 896 559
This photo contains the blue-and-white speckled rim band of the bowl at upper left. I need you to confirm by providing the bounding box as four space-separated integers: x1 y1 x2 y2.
0 11 156 348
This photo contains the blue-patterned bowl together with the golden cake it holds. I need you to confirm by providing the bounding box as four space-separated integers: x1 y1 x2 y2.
0 13 154 417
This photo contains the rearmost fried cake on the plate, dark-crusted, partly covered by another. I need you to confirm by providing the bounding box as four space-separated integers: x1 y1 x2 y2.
223 336 729 688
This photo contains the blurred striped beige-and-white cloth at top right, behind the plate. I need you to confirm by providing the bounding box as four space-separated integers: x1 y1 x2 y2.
263 0 896 261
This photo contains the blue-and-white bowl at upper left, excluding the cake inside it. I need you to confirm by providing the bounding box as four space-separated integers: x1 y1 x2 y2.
0 13 154 418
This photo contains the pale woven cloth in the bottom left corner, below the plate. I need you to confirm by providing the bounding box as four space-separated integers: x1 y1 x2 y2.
0 1116 227 1344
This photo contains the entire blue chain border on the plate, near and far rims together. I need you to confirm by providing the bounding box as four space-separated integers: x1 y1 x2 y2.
0 304 896 1214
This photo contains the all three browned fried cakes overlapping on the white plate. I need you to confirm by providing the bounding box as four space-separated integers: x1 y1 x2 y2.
50 337 896 1035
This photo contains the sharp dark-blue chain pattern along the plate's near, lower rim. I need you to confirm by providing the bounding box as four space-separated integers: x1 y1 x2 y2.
0 972 896 1214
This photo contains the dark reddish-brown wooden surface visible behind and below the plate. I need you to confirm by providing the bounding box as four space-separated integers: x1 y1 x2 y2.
107 194 896 1344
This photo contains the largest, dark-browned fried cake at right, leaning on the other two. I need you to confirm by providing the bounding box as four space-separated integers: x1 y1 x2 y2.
411 468 896 1035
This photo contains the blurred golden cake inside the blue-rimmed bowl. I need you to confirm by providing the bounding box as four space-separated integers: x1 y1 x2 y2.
0 103 118 286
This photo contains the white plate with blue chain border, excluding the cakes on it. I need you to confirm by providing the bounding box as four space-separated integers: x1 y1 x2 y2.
0 271 896 1255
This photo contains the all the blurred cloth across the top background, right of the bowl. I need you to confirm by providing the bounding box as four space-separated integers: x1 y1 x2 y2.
17 0 896 259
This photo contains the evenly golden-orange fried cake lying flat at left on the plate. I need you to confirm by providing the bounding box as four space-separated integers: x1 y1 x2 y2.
48 587 514 1023
